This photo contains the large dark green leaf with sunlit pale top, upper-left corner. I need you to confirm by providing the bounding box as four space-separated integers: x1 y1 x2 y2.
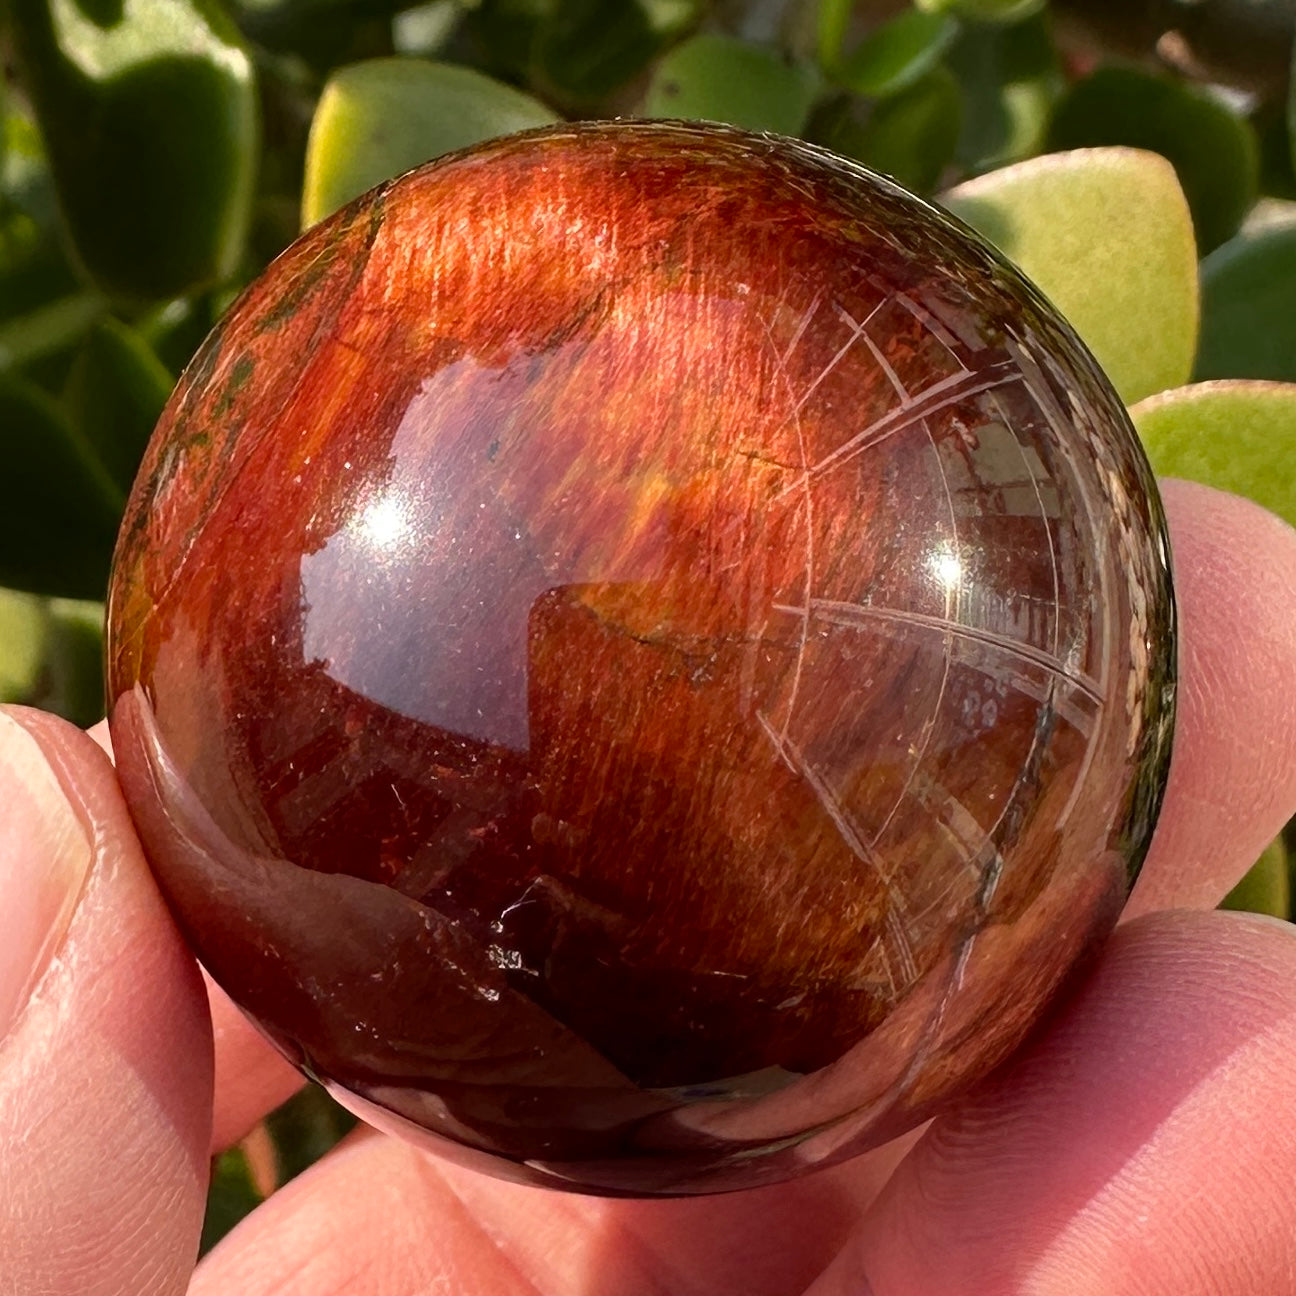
9 0 259 299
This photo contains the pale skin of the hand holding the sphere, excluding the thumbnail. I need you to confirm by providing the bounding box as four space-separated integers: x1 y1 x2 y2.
0 482 1296 1296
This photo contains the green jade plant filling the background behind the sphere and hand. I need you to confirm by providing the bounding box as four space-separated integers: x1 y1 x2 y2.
0 0 1296 1242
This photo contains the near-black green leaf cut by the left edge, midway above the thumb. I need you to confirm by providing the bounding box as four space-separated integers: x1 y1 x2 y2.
0 376 124 599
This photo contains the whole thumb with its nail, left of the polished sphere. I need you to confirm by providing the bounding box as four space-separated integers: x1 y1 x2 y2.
0 709 211 1296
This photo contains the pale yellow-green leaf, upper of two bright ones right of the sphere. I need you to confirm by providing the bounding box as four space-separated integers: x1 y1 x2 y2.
942 149 1198 403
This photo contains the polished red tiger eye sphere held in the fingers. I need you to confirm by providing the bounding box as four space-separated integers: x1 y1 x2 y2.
109 123 1173 1194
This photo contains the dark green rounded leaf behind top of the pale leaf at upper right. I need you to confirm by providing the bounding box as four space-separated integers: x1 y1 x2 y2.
1048 67 1260 253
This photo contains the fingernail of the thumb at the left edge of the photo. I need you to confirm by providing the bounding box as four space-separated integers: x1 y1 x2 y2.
0 712 93 1039
